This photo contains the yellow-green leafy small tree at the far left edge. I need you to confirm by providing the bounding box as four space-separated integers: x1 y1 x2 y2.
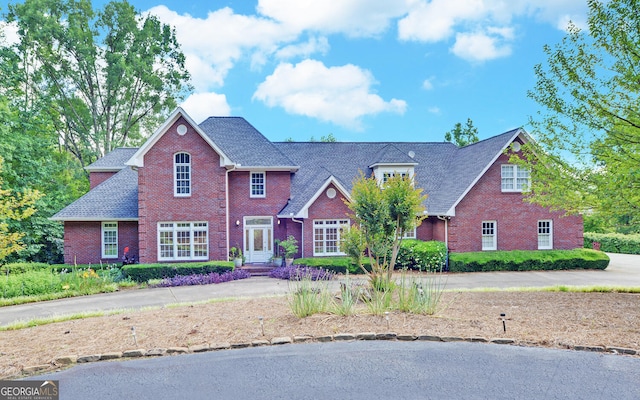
0 157 42 262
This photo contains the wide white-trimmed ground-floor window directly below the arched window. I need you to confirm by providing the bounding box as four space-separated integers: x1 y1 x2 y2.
158 222 209 261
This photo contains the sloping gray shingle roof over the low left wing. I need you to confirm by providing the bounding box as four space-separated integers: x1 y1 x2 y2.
51 168 138 221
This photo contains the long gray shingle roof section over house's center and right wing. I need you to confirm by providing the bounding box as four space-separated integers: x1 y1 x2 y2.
274 129 518 216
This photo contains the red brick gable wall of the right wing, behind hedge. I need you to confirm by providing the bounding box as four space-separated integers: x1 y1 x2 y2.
449 154 583 252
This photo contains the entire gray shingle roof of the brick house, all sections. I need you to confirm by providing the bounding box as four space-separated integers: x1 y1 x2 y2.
52 117 520 221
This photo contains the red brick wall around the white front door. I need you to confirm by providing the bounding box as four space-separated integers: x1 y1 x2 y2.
229 170 291 255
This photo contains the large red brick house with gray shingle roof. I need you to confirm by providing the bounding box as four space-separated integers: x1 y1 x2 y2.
52 108 583 263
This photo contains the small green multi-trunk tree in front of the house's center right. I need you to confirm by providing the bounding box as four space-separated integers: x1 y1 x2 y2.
342 174 427 289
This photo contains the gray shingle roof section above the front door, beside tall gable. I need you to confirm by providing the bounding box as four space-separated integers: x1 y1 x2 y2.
199 117 297 169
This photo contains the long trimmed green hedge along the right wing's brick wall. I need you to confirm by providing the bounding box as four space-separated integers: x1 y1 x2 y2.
449 249 609 272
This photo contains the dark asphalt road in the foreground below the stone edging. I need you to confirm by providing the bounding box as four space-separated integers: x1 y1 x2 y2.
32 341 640 400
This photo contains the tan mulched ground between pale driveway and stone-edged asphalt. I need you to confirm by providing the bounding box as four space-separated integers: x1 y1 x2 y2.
0 291 640 378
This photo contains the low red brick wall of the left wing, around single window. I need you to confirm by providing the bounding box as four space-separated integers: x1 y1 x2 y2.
64 221 138 264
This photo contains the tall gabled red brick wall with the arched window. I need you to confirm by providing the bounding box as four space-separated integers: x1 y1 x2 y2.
138 118 227 263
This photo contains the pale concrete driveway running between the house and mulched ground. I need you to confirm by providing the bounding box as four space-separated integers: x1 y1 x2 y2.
0 254 640 326
